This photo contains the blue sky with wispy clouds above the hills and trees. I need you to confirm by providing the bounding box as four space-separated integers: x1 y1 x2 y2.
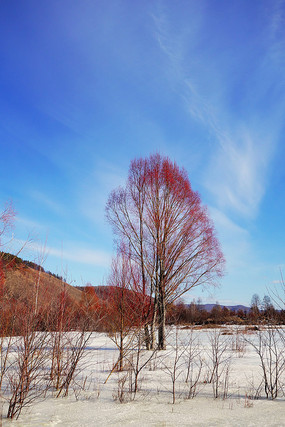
0 0 285 304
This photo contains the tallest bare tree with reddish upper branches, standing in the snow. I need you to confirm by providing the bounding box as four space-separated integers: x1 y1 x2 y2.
106 154 224 349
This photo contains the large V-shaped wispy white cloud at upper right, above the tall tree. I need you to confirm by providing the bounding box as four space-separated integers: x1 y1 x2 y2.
154 2 285 217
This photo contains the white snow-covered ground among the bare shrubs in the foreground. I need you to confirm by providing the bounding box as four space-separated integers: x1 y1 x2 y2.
2 327 285 426
